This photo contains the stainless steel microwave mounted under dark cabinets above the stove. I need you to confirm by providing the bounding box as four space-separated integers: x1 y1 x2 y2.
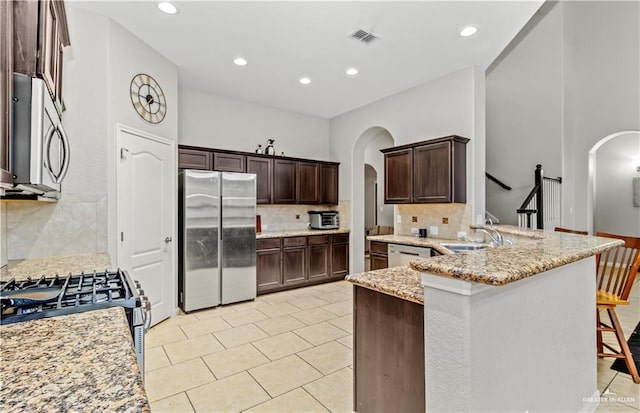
10 73 70 198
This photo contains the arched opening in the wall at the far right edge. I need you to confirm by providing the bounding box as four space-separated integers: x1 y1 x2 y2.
587 131 640 237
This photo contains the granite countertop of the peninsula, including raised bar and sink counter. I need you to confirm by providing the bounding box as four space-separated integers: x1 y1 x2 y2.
346 226 623 302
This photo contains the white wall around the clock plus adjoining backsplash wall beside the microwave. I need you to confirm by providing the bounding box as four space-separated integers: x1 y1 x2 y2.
6 3 178 263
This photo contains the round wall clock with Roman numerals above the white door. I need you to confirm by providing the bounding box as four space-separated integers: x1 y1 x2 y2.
130 73 167 123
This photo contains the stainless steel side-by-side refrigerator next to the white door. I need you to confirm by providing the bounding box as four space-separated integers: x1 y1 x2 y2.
178 169 256 312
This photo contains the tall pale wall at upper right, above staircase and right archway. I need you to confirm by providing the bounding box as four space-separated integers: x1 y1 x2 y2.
486 1 640 228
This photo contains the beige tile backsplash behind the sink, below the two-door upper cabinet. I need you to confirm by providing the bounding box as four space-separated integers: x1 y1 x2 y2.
394 204 473 239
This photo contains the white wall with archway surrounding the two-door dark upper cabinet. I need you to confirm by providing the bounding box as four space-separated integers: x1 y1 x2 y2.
330 68 485 272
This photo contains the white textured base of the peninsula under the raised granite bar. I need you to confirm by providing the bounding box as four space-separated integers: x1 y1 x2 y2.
422 256 599 412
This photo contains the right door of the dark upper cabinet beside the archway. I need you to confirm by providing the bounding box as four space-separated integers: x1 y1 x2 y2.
413 142 452 202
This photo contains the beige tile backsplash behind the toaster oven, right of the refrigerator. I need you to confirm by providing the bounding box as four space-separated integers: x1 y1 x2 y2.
256 201 349 232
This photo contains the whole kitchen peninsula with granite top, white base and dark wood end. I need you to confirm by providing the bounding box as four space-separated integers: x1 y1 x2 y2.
347 226 622 413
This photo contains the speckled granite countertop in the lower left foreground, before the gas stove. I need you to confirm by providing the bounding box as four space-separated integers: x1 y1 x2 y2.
0 307 150 412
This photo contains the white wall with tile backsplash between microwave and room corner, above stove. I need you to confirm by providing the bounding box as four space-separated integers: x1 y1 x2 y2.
6 7 109 259
